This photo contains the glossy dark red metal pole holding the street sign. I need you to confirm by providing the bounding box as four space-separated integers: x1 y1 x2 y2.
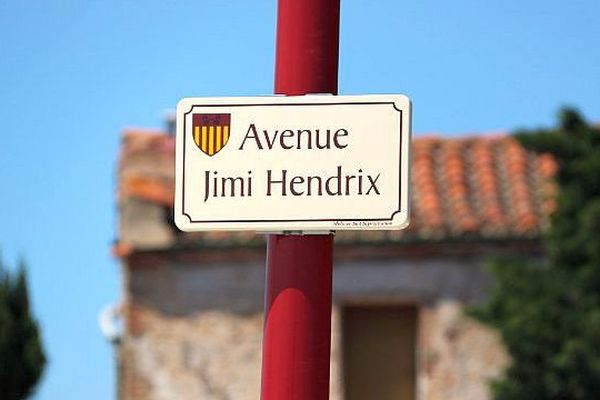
261 0 340 400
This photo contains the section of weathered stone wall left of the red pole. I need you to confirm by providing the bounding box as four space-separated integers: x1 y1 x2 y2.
121 263 264 400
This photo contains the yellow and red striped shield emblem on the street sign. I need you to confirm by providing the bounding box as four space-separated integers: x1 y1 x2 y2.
192 114 231 157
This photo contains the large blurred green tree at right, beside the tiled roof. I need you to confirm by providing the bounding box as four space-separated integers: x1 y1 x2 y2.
473 109 600 400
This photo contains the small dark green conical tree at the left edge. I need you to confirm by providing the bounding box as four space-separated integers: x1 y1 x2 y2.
0 260 46 400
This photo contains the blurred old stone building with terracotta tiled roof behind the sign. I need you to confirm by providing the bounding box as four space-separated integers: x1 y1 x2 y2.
114 131 556 400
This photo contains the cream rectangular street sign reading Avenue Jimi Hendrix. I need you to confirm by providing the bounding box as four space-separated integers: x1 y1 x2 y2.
175 95 411 231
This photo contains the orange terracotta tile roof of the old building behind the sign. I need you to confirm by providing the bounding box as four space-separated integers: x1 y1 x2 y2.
118 130 558 252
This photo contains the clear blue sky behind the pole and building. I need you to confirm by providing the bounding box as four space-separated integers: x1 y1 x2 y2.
0 0 600 400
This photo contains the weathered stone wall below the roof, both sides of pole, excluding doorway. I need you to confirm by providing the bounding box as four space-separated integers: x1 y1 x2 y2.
120 258 506 400
